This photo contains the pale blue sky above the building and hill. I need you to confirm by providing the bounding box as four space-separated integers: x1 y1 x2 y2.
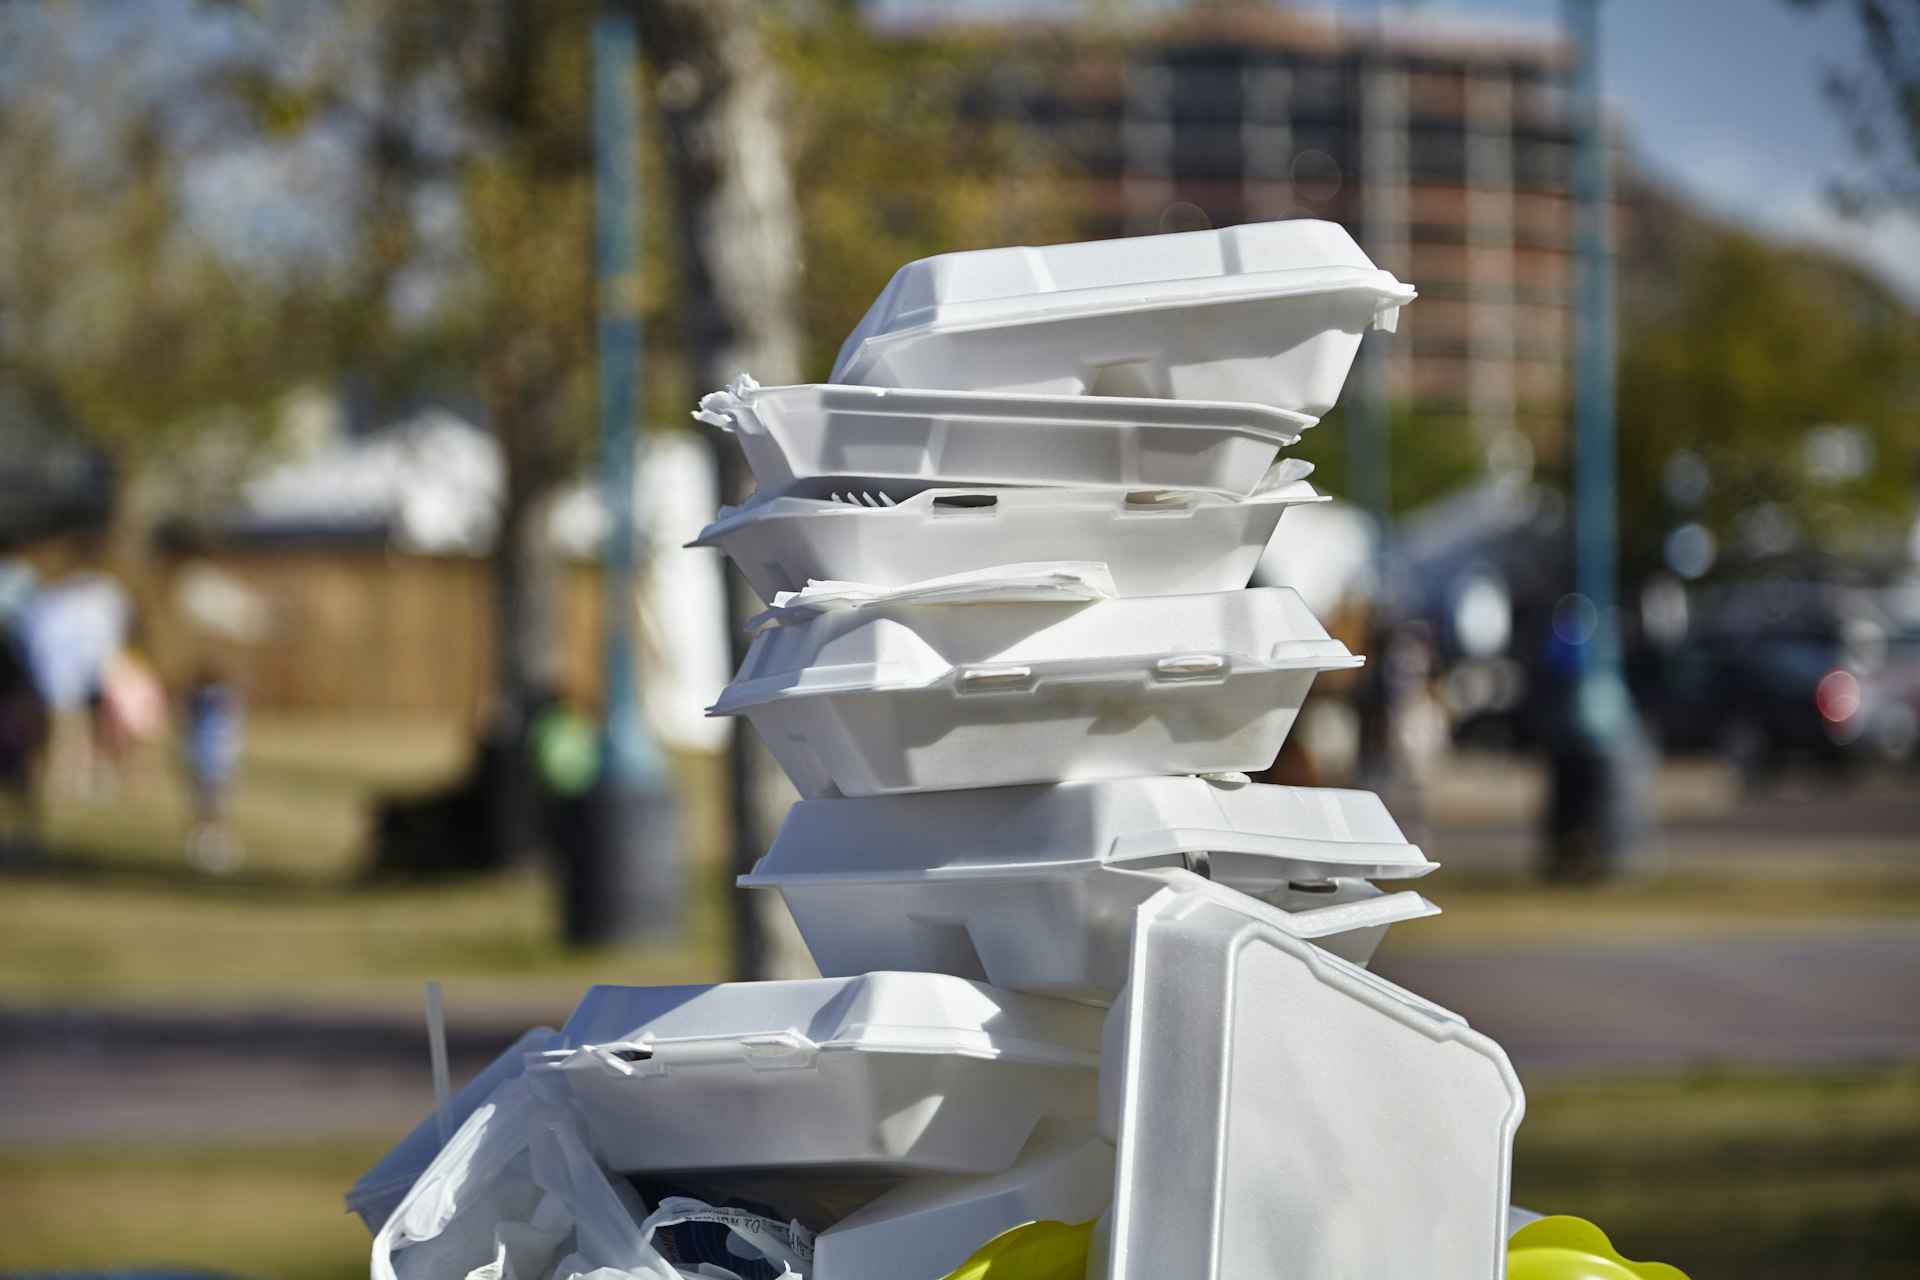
874 0 1920 305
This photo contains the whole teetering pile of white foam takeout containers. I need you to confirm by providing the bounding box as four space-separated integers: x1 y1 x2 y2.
349 221 1523 1280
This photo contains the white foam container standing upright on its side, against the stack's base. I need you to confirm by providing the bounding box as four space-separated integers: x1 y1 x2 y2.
1087 886 1524 1280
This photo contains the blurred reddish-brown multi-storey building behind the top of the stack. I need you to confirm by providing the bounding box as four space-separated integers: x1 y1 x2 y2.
948 6 1572 441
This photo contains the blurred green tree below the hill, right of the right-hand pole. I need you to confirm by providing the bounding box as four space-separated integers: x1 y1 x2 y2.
1620 186 1920 578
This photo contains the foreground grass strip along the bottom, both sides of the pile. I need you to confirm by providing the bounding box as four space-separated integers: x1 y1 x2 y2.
0 1069 1920 1280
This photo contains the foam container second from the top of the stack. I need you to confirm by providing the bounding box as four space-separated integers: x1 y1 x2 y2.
695 374 1313 498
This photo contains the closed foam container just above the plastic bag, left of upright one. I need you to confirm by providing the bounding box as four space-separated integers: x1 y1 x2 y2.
532 973 1100 1174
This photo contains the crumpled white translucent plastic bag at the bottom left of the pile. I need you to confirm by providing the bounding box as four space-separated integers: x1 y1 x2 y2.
372 1077 812 1280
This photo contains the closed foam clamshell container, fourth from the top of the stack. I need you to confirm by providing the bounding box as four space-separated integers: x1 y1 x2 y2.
708 587 1359 796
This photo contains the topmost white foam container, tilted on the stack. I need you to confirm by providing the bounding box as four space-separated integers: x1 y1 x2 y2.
831 219 1413 416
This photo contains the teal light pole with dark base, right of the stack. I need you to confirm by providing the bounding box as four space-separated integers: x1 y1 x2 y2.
1548 0 1647 879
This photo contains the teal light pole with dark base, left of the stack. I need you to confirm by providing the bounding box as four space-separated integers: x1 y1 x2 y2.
566 6 682 944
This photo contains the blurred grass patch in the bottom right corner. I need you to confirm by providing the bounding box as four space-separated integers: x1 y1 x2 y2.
1513 1067 1920 1280
